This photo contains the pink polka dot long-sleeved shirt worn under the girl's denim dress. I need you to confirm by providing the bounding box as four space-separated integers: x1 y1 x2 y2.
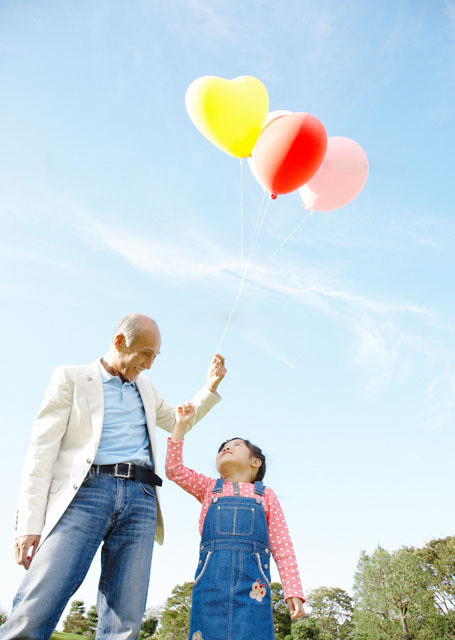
166 438 305 602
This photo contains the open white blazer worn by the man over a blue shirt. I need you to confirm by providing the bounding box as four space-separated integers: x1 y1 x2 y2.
16 360 221 544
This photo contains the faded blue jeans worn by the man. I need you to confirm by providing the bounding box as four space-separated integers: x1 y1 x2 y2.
0 470 157 640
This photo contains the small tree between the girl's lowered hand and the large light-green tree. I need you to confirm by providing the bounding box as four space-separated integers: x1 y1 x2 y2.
307 587 353 640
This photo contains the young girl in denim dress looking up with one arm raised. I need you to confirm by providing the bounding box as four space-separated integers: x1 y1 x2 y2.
166 403 305 640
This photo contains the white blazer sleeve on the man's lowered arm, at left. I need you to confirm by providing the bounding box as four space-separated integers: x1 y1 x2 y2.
15 367 73 537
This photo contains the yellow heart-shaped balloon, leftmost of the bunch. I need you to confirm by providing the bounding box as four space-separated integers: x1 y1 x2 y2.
185 76 269 158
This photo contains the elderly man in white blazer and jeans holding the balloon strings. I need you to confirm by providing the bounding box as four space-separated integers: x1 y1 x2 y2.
0 314 226 640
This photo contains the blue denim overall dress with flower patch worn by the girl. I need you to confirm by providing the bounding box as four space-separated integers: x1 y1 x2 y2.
189 478 275 640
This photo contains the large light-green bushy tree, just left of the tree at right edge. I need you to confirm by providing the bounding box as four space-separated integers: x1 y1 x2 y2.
354 547 437 640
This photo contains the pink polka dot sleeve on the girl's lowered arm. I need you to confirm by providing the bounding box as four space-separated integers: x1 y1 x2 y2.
265 488 305 602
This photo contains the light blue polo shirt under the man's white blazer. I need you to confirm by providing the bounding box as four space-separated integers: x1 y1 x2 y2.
93 362 153 468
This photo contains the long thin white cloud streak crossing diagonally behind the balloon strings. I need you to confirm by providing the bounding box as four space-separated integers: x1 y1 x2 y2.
78 211 448 323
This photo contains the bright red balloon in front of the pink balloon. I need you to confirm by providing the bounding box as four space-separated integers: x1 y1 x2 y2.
254 113 327 194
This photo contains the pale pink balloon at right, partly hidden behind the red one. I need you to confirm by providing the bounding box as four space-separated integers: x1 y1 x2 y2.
299 136 368 211
